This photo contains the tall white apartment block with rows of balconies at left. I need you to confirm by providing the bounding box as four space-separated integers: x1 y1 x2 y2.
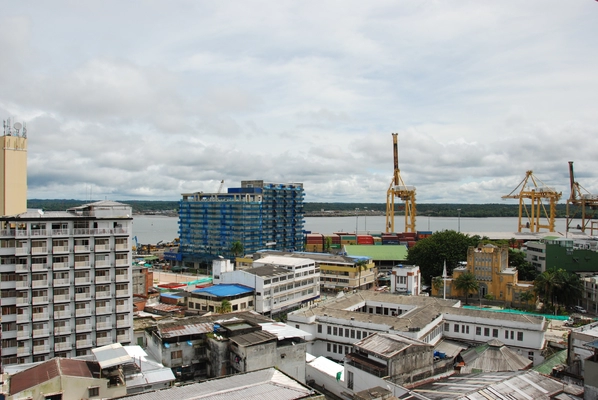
0 201 133 365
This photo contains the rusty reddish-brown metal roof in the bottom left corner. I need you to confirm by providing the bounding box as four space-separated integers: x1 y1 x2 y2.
10 358 100 395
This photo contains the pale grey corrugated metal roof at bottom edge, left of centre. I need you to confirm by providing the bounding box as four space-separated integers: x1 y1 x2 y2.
117 368 316 400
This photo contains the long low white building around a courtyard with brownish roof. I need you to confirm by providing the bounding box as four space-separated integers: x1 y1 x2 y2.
287 291 547 364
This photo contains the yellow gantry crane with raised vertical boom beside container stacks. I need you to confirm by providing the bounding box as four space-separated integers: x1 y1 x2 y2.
385 133 415 232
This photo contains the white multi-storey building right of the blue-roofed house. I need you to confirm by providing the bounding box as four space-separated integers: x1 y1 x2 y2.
213 256 320 315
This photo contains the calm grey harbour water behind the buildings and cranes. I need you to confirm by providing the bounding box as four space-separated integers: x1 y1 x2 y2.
133 215 581 244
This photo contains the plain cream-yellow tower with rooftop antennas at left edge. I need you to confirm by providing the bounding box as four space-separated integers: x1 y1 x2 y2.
0 119 27 216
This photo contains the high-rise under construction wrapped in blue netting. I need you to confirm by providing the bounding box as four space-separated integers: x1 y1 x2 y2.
179 180 304 264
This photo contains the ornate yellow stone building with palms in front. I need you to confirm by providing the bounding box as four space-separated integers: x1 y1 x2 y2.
432 244 534 304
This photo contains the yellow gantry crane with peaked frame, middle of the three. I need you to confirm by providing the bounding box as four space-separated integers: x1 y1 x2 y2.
502 171 562 232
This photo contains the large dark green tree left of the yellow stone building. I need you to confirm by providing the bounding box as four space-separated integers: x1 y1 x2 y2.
407 231 481 284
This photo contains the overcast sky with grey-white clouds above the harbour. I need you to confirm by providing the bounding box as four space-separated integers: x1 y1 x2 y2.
0 0 598 203
